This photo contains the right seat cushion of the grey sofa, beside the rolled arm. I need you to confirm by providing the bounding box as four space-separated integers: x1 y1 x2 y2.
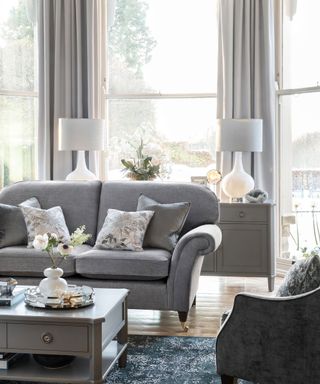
76 249 171 280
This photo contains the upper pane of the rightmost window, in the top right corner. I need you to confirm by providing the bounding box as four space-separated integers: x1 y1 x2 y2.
283 0 320 88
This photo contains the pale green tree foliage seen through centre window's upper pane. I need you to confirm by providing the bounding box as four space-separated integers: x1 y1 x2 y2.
109 0 156 74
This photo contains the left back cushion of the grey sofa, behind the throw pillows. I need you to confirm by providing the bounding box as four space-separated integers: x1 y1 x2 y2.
0 180 101 245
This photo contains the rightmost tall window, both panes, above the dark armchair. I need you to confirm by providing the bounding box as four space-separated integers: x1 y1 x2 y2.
278 0 320 259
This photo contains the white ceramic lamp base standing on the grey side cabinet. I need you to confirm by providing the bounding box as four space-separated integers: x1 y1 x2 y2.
221 152 254 202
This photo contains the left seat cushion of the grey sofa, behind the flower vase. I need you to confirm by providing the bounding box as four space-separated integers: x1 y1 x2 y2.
0 245 92 277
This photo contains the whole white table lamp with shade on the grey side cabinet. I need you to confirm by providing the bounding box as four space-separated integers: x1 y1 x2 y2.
216 119 262 202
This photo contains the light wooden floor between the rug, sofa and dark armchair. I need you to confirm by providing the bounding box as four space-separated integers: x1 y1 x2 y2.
129 276 282 336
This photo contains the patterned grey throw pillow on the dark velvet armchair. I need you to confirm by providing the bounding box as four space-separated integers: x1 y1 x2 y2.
277 255 320 297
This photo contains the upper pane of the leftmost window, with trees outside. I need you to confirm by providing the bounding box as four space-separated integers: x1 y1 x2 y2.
0 0 37 91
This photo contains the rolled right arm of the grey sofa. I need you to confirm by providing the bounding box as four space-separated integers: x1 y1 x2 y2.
167 224 222 312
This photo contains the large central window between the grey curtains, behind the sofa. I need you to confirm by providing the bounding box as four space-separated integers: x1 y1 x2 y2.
106 0 217 181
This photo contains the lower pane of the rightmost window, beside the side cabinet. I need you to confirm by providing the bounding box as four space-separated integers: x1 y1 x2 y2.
280 93 320 256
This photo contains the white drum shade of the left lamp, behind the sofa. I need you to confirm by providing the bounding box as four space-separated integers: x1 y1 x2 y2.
59 118 105 151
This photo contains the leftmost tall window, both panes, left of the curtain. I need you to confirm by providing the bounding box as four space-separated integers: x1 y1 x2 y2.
0 0 38 188
